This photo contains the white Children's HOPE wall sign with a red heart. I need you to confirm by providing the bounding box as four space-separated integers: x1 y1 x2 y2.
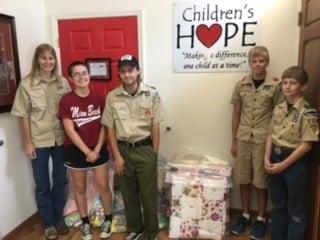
173 0 263 72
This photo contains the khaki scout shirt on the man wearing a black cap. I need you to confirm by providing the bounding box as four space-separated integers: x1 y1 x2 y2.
101 83 163 142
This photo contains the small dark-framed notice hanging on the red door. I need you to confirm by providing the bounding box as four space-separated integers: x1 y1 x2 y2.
86 58 111 80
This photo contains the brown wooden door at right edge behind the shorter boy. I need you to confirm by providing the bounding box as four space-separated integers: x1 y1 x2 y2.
299 0 320 240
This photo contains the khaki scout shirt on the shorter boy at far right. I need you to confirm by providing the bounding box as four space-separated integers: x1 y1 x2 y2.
270 97 319 148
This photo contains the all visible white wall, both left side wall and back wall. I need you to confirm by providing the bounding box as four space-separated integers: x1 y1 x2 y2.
0 0 300 235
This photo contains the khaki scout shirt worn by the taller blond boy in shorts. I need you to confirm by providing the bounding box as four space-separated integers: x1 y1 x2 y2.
231 74 284 143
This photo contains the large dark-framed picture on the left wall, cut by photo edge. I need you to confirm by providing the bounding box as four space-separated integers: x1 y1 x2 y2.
0 14 20 113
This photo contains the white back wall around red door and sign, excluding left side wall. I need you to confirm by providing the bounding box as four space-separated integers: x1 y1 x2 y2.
45 0 300 208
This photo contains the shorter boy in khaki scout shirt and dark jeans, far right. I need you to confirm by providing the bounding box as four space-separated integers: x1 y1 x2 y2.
265 66 319 240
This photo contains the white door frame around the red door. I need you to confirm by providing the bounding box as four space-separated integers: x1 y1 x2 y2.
50 9 148 82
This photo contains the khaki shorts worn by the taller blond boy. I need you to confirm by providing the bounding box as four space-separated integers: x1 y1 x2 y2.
234 140 267 189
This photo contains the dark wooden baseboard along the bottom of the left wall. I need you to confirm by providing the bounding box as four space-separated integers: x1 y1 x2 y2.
2 212 41 240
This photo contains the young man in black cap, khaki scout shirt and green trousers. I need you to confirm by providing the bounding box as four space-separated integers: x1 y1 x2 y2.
102 55 161 240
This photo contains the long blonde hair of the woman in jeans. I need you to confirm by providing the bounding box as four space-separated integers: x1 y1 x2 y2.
28 43 61 86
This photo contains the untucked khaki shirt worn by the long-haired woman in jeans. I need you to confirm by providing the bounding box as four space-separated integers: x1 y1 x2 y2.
11 74 70 148
